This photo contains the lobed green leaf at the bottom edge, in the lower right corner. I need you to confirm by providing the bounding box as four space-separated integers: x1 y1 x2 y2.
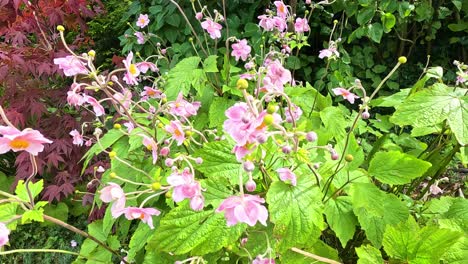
383 217 461 264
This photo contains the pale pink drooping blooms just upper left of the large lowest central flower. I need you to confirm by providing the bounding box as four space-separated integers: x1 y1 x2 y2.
167 168 205 211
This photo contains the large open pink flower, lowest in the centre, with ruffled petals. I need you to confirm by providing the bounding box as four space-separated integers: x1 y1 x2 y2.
216 194 268 226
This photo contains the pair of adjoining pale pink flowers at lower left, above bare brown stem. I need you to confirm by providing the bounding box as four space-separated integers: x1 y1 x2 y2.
99 182 161 229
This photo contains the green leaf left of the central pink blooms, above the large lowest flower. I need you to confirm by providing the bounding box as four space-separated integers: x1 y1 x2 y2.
194 141 241 182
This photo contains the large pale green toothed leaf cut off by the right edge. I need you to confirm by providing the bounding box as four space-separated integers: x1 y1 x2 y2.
390 83 468 145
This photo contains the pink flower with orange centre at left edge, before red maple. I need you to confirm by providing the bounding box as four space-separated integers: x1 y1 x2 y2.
0 126 52 156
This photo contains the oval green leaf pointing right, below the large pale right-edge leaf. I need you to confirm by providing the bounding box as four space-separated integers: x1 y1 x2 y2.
369 151 432 184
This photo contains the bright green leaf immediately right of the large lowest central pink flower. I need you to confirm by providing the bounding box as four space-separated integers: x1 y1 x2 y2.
267 175 325 251
